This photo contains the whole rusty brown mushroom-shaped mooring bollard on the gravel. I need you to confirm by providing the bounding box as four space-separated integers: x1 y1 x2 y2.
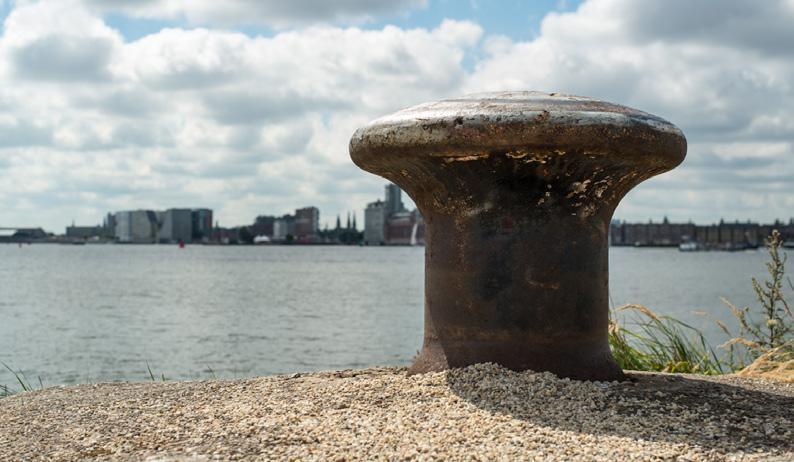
350 92 686 380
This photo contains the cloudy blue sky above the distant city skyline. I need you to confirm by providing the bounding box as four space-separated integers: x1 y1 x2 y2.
0 0 794 233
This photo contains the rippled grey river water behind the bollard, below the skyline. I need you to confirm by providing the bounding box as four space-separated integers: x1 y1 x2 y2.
0 245 780 385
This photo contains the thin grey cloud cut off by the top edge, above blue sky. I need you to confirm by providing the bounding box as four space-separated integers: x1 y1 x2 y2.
79 0 427 27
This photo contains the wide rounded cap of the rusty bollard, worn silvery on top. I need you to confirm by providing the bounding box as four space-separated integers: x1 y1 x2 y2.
350 91 686 171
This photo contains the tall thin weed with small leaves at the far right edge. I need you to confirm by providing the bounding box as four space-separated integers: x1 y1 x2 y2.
721 230 794 360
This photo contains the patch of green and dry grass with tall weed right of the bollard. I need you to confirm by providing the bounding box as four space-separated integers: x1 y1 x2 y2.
609 230 794 382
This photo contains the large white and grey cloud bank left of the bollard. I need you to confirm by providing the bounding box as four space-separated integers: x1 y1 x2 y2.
0 0 482 231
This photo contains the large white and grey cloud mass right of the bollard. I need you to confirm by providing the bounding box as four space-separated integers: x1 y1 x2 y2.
465 0 794 220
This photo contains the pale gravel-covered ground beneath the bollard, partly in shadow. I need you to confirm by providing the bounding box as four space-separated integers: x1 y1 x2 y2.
0 364 794 461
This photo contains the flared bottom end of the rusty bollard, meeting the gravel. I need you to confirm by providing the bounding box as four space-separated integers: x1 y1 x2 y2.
408 341 627 382
